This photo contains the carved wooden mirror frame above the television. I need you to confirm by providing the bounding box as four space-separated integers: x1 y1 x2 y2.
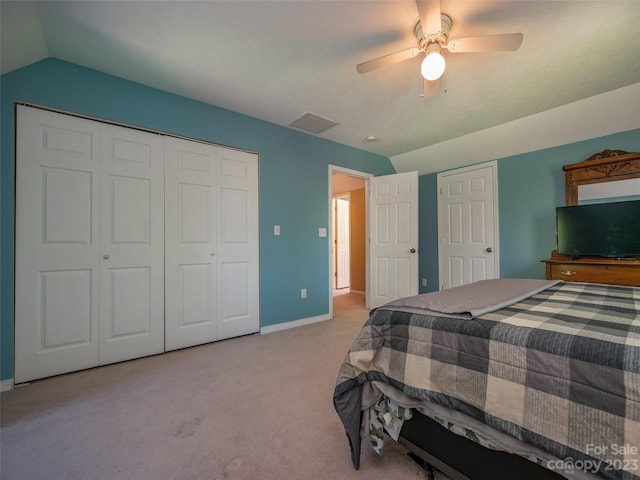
562 150 640 205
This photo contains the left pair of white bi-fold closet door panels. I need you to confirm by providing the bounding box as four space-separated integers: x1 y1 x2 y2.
15 106 164 382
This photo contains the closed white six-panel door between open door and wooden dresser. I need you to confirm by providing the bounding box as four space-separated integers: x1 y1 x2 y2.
438 162 500 289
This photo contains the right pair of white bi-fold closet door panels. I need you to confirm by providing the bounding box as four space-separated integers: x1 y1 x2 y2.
165 137 259 350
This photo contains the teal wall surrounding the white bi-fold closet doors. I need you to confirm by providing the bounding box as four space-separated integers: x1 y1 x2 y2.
0 59 395 379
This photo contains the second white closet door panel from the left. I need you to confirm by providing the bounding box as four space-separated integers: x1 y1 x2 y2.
100 124 164 364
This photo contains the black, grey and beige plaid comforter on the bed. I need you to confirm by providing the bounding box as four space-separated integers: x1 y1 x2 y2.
334 280 640 480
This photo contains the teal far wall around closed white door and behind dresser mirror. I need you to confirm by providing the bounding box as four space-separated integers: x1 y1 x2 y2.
419 129 640 293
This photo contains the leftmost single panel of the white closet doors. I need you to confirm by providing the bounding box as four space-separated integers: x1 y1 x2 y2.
14 105 100 383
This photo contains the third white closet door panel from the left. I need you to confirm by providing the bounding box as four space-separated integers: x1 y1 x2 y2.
165 137 217 350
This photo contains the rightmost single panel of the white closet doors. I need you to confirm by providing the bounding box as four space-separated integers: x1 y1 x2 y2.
216 147 260 339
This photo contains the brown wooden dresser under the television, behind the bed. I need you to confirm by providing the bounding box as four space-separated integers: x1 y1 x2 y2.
542 250 640 287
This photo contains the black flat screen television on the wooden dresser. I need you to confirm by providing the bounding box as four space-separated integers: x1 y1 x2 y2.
556 200 640 258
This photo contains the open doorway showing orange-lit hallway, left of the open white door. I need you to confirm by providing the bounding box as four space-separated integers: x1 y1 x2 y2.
329 165 373 317
